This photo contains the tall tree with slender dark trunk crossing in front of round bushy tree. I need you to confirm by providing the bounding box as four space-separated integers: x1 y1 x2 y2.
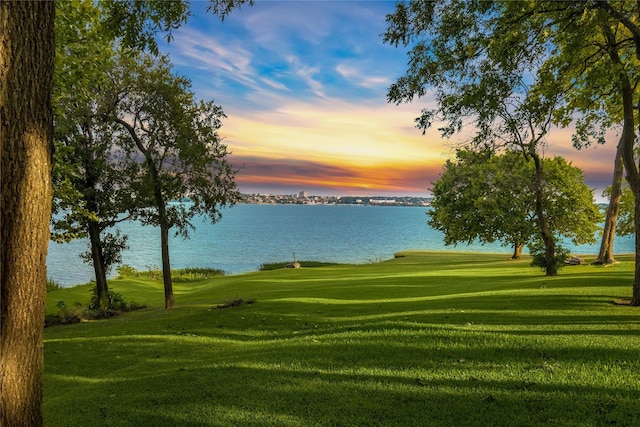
384 1 576 276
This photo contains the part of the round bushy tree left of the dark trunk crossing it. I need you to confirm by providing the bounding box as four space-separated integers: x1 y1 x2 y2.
429 150 535 259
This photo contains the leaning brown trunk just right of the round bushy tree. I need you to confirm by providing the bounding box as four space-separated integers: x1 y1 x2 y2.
594 138 624 265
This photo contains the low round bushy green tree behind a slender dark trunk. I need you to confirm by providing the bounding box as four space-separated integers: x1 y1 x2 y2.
430 151 601 267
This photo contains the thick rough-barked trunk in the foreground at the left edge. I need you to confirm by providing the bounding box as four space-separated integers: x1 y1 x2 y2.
0 0 55 427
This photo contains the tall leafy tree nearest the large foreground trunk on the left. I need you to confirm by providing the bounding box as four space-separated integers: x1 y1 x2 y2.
52 1 131 309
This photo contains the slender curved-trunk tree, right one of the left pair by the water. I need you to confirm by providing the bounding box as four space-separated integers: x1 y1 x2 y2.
111 56 240 308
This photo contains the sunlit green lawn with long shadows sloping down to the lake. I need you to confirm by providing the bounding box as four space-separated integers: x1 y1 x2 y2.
44 252 640 427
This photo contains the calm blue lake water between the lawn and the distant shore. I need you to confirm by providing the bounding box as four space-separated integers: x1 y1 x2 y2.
47 205 634 285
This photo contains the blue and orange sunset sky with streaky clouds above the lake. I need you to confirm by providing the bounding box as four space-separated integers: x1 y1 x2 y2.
160 0 617 199
